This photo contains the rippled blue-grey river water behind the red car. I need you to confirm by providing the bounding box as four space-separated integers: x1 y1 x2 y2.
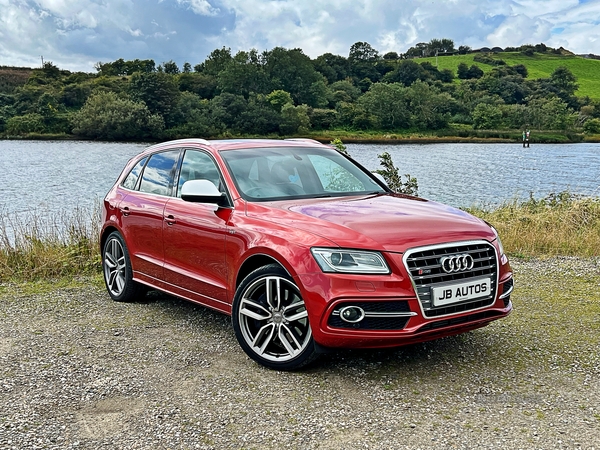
0 140 600 214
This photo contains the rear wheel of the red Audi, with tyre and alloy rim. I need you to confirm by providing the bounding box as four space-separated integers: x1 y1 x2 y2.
102 231 146 302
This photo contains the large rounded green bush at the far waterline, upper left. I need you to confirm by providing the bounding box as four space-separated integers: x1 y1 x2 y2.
72 92 164 139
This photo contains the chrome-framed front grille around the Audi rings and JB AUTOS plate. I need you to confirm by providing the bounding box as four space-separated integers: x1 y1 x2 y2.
403 240 498 318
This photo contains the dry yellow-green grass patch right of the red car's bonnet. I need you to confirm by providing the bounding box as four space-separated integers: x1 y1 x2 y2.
467 192 600 257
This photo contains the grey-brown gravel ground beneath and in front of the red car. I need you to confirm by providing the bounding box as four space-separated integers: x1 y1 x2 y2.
0 258 600 449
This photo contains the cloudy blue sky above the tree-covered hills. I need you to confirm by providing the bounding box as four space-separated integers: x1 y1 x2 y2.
0 0 600 73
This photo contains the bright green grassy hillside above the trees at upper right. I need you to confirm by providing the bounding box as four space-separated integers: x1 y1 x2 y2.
419 52 600 99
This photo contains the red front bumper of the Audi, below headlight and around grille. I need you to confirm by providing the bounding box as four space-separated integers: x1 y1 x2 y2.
298 251 513 348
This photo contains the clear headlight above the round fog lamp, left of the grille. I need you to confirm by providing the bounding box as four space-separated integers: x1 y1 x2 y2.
310 248 390 273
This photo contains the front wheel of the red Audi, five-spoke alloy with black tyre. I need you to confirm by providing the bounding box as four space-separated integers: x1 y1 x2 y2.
231 264 317 370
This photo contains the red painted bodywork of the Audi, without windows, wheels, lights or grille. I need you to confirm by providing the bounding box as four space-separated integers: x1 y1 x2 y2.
101 140 512 347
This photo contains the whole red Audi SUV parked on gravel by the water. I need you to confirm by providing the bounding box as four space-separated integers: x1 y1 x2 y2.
100 139 513 370
